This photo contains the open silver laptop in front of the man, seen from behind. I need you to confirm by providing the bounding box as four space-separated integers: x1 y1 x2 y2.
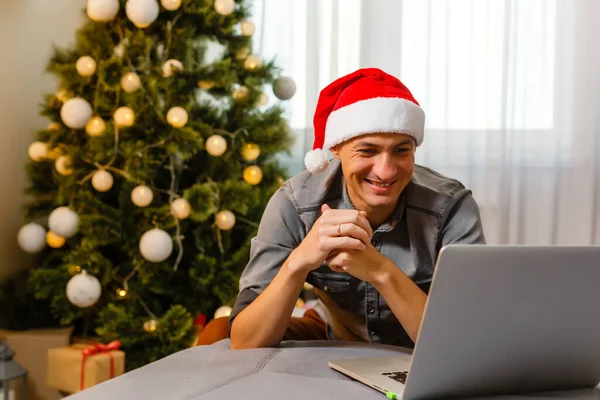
329 245 600 400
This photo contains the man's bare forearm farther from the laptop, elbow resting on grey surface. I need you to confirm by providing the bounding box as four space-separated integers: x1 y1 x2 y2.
230 256 307 349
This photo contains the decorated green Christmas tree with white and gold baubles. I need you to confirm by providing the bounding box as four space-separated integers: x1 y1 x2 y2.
18 0 295 369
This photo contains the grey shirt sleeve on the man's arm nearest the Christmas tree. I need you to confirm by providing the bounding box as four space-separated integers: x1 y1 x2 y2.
229 187 305 332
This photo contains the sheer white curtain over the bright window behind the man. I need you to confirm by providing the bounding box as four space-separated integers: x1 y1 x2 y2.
253 0 600 244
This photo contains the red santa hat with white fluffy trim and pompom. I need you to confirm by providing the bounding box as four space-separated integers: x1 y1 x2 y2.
304 68 425 174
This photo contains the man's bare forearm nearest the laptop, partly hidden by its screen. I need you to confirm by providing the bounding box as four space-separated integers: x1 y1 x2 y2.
373 261 427 342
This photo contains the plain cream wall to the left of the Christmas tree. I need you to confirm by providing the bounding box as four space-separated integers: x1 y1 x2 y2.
0 0 85 279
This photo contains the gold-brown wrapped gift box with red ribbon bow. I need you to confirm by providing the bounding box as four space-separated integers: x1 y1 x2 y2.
46 342 125 393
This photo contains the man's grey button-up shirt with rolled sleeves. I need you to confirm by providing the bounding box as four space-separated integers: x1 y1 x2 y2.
230 160 485 347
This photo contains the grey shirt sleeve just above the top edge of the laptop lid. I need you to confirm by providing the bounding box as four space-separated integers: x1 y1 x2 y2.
441 190 485 247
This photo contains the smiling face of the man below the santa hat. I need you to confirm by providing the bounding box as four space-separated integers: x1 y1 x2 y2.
331 133 416 213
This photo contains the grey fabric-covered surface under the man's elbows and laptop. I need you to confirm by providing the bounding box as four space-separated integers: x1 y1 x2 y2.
67 340 600 400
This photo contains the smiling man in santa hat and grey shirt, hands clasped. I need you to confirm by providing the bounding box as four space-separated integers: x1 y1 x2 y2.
230 68 485 349
